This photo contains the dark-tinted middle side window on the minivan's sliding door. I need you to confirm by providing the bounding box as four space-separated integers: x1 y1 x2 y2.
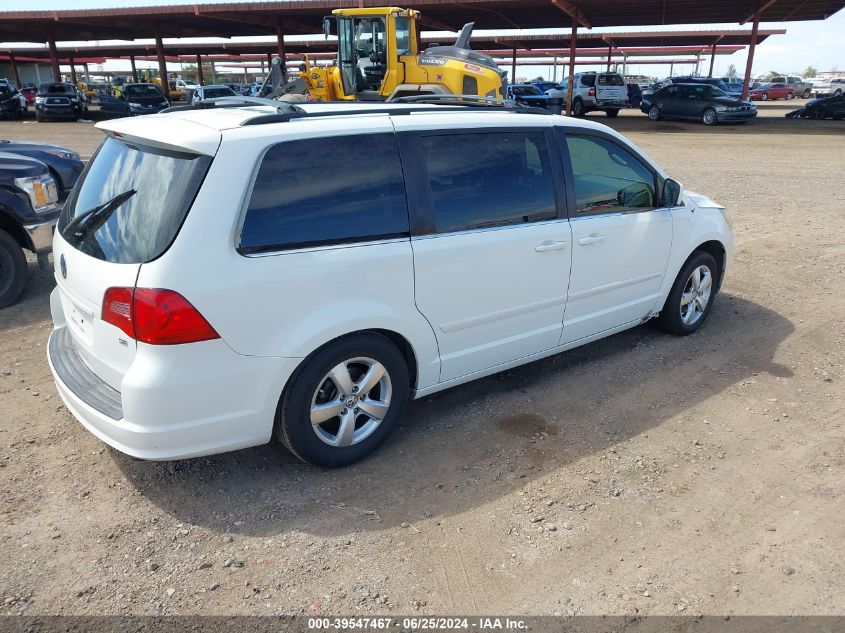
420 131 557 233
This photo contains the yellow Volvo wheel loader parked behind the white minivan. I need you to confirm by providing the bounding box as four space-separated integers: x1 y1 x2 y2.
261 7 506 101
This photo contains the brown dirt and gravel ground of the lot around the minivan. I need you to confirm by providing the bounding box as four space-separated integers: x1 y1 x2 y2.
0 104 845 615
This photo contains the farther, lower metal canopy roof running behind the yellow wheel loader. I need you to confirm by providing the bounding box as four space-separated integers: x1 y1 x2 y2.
0 29 786 60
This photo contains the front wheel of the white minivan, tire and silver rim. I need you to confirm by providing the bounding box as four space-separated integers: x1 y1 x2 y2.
658 251 720 336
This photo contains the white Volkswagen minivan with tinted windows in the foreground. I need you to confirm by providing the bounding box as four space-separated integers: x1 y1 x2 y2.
48 97 733 466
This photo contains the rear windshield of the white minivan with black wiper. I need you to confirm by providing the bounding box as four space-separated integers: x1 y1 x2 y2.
58 137 211 264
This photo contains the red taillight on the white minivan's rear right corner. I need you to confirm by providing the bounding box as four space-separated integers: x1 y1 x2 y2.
101 288 220 345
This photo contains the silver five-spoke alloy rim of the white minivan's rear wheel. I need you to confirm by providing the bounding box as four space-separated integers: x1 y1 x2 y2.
311 357 393 447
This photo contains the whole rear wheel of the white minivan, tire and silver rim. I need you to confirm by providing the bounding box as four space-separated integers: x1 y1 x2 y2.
276 334 410 468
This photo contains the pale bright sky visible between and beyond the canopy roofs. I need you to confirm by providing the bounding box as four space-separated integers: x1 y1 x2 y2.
0 0 845 77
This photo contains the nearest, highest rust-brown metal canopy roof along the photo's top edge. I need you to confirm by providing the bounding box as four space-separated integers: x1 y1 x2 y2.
0 0 845 42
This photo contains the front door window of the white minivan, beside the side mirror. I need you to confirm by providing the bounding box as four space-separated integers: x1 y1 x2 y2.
566 136 657 215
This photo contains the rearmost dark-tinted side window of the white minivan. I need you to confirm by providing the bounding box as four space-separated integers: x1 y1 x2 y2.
238 134 410 253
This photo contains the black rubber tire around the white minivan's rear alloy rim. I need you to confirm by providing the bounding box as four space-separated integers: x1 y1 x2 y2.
275 334 410 468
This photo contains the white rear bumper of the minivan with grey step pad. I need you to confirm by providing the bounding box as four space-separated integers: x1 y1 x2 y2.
47 316 299 461
